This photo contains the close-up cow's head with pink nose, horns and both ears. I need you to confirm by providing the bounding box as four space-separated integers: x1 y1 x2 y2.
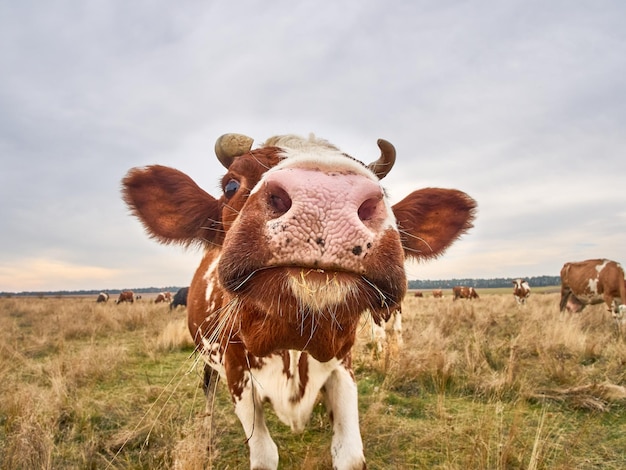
123 135 476 360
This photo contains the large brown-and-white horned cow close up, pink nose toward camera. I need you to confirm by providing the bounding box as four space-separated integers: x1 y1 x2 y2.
122 134 476 469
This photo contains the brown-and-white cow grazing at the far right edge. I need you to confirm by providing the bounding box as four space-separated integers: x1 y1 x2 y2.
560 259 626 314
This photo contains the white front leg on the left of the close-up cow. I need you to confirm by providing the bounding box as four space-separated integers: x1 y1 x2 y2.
235 372 278 470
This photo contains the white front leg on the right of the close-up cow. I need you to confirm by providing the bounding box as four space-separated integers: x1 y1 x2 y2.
324 366 366 470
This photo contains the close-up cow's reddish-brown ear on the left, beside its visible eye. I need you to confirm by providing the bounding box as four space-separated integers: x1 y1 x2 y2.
122 165 223 246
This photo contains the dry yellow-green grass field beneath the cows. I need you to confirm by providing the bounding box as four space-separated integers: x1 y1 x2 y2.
0 289 626 470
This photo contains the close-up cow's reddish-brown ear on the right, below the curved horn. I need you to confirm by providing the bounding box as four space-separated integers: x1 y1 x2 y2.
392 188 476 259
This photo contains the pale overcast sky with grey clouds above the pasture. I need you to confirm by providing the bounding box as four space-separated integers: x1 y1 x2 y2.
0 0 626 292
